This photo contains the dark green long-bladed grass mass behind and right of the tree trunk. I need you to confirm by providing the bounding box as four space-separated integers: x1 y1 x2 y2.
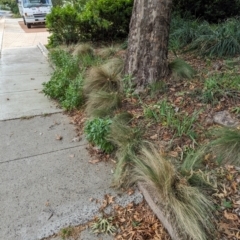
169 15 240 57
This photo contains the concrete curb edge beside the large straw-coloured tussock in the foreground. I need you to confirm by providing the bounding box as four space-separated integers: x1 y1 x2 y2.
137 182 182 240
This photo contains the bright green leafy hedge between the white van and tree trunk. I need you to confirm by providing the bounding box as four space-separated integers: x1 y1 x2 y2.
47 0 133 46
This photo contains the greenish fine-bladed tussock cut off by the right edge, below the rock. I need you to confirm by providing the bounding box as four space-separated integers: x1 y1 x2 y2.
209 127 240 165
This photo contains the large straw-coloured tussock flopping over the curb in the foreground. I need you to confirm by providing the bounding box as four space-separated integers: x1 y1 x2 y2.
134 146 214 240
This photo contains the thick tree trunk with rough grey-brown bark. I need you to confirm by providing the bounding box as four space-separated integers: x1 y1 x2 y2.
125 0 172 88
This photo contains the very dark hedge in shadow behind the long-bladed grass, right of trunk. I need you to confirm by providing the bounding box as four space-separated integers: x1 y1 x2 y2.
173 0 240 22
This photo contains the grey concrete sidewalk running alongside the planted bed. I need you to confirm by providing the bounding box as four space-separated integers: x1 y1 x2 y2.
0 15 142 240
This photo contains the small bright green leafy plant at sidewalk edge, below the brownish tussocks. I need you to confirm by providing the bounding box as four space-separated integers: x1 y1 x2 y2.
84 118 114 153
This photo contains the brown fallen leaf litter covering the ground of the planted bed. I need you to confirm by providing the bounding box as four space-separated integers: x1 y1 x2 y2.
68 49 240 240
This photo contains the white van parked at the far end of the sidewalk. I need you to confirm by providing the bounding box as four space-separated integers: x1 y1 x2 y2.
17 0 52 28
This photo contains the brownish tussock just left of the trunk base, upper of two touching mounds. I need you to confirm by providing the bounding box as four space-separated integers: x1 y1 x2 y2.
83 59 123 95
